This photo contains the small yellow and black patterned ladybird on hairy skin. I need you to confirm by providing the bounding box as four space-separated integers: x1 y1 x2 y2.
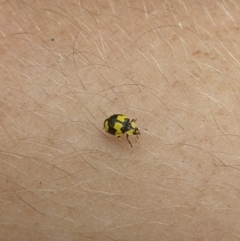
103 114 140 147
